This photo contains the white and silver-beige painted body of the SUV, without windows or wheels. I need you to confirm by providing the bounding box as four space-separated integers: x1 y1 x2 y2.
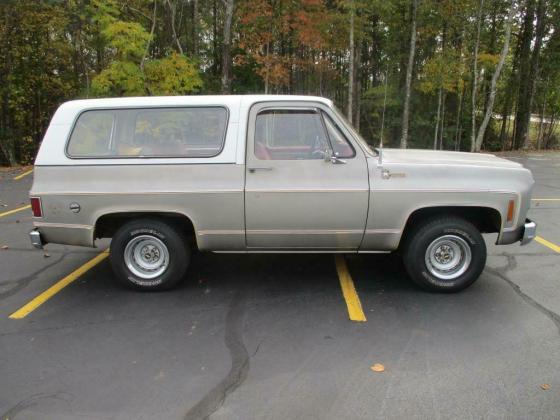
30 95 534 252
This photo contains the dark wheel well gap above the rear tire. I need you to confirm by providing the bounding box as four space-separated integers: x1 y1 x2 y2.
94 212 197 248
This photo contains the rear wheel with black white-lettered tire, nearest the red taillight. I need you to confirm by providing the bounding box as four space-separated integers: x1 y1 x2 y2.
110 219 190 291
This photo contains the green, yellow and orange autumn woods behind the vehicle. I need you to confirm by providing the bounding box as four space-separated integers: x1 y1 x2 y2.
0 0 560 163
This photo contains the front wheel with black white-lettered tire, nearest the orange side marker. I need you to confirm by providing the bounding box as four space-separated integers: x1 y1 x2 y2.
403 216 486 293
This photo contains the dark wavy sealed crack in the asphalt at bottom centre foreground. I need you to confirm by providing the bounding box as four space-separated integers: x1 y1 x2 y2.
184 291 249 420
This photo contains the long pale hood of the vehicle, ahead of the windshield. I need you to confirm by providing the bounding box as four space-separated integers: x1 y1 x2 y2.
382 148 523 169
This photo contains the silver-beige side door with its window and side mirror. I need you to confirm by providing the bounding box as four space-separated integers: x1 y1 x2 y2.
245 102 369 250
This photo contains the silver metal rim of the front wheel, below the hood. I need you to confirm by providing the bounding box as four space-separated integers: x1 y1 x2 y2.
425 235 472 280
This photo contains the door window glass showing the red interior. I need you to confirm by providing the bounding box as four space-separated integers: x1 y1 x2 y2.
254 109 329 160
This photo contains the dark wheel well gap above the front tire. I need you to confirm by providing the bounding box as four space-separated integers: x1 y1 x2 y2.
399 206 502 247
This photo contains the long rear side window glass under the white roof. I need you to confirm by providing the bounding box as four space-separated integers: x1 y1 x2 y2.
67 107 228 158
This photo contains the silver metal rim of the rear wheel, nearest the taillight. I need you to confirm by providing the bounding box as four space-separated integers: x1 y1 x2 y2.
124 235 169 280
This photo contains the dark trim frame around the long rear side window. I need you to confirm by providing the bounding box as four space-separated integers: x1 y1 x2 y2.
64 105 230 160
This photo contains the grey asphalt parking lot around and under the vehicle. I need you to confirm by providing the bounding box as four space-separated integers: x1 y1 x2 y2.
0 153 560 419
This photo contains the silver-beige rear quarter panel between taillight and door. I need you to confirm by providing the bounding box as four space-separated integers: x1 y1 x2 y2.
31 164 245 249
